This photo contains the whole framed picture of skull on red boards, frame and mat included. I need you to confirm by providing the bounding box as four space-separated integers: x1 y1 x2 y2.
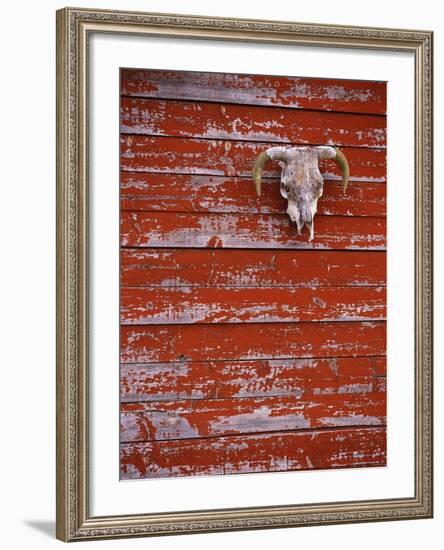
56 8 433 541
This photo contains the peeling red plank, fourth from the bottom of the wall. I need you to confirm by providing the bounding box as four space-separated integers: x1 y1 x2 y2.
120 321 386 363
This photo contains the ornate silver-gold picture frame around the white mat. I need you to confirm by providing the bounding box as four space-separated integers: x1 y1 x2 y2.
56 8 433 541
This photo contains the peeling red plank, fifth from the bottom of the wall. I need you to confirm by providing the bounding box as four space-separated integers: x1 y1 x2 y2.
120 287 386 325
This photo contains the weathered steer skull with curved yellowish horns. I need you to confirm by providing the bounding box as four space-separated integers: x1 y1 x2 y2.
253 146 350 241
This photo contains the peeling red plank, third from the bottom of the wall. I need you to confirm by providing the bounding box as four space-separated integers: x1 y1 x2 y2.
120 357 386 402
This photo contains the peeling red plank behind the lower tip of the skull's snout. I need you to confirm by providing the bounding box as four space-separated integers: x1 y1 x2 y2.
121 212 386 250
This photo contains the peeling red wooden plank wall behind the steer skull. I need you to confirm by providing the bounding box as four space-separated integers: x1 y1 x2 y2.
120 70 386 479
